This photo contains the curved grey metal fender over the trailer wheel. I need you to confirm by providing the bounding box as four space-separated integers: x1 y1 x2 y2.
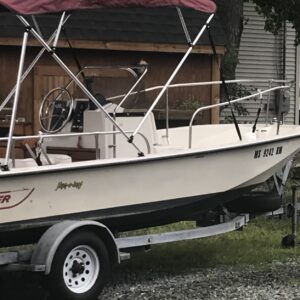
31 221 121 275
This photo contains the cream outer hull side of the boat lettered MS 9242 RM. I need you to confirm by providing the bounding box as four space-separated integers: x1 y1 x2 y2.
0 125 299 239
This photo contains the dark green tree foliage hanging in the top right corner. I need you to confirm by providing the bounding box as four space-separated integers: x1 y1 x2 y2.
253 0 300 44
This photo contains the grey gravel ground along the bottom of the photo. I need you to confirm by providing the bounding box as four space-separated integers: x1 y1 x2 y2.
0 260 300 300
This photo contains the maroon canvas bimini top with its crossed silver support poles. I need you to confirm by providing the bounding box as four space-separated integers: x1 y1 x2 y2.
0 0 216 170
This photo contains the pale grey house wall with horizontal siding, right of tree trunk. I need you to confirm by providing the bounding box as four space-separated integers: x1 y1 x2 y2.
236 1 300 124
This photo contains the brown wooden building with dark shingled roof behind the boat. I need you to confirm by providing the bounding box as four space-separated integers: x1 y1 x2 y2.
0 8 225 137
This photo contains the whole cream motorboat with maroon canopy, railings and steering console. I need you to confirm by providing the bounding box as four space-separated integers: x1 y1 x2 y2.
0 0 300 246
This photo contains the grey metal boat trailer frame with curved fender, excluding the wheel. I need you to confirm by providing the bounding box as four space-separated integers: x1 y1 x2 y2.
0 214 249 275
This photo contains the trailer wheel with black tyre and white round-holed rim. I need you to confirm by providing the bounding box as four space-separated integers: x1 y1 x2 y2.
48 230 110 300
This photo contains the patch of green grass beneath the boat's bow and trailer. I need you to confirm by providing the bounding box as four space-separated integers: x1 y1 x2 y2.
121 218 300 273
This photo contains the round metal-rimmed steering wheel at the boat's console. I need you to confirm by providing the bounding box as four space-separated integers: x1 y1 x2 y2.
39 87 74 133
